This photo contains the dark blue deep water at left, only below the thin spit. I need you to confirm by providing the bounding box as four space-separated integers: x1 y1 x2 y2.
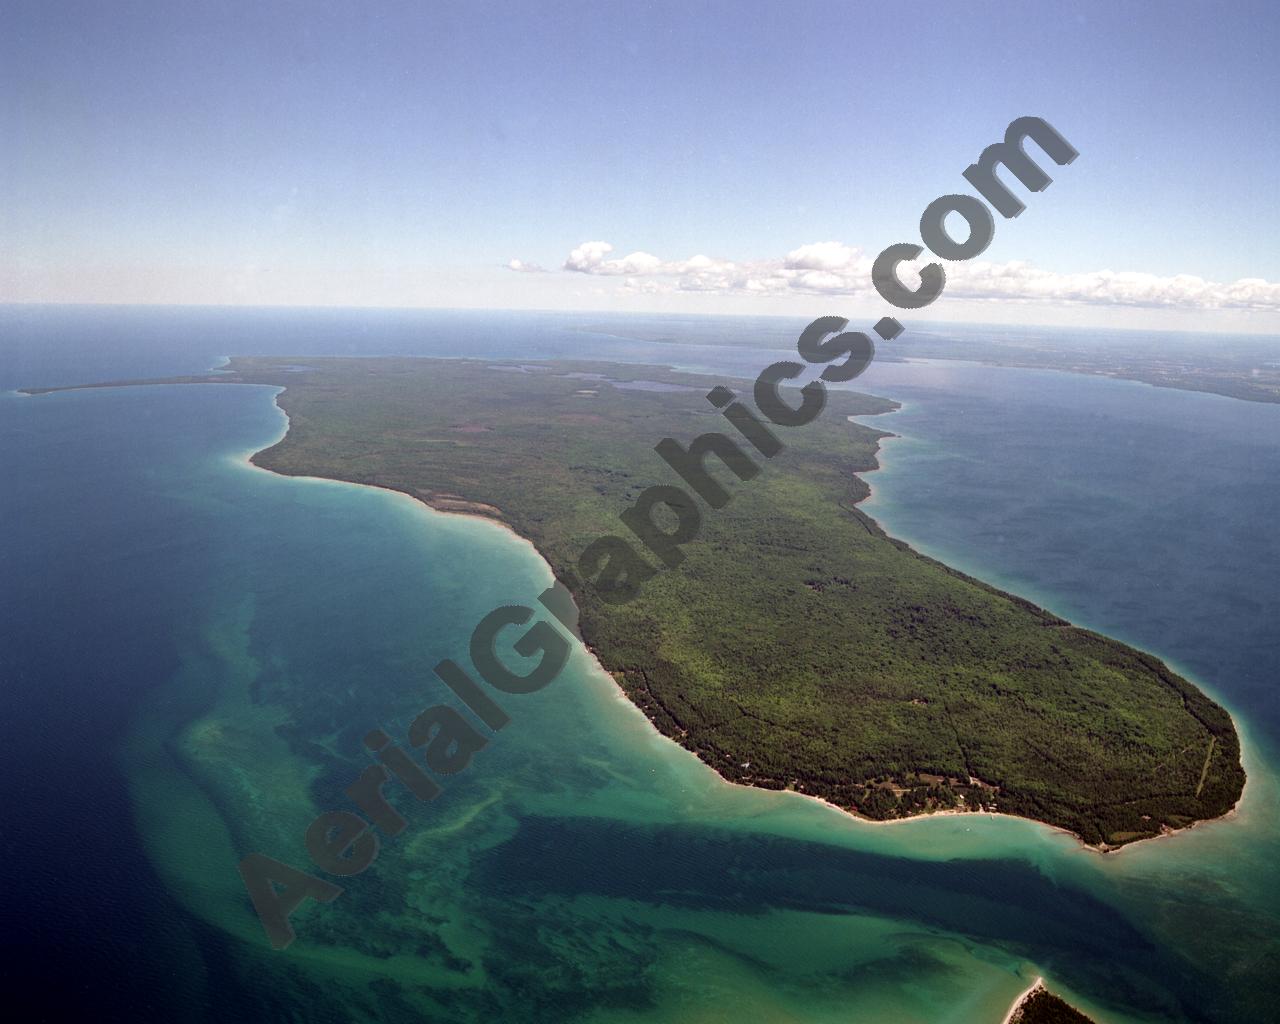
0 389 264 1020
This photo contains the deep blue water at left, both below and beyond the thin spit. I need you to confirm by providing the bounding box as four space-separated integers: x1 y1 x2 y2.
0 306 793 1020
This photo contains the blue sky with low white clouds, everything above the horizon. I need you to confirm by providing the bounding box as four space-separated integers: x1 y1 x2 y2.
0 0 1280 333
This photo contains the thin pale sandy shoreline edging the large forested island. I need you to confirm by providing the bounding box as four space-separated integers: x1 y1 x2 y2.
232 376 1248 855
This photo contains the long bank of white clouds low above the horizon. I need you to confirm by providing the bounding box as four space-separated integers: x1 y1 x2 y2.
532 241 1280 312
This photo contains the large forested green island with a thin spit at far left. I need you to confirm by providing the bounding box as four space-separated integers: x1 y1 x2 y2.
28 357 1244 850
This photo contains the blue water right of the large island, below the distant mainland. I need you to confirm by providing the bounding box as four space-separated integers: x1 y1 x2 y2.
868 361 1280 741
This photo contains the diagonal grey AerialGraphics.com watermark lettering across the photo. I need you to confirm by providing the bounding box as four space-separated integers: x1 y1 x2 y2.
239 116 1078 950
